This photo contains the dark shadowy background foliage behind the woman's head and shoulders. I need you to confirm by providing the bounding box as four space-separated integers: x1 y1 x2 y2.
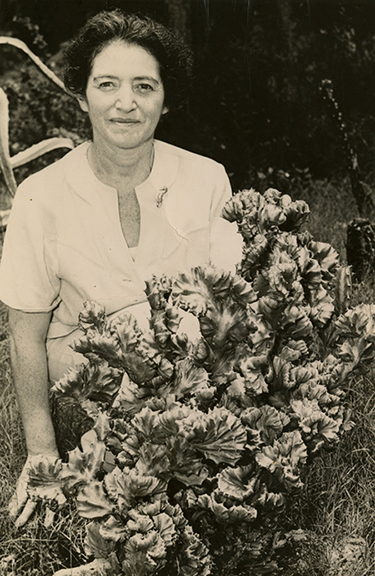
0 0 375 194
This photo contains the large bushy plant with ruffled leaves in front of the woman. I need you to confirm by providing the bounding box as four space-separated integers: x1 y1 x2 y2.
25 190 375 576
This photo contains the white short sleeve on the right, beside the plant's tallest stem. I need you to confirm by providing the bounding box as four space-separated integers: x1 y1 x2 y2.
210 165 242 273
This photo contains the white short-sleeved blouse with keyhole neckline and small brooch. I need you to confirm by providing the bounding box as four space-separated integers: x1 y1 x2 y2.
0 141 242 338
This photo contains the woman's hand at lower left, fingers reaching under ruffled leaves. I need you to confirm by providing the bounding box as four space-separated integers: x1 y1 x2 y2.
8 452 60 528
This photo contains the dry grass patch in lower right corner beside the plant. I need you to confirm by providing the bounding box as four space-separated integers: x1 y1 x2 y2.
288 375 375 576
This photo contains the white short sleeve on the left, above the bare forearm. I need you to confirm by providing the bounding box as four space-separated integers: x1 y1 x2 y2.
0 176 60 312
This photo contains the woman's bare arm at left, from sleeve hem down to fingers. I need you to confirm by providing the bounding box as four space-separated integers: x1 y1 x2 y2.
9 308 59 526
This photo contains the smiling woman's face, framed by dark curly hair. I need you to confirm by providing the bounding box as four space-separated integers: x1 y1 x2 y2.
79 41 167 149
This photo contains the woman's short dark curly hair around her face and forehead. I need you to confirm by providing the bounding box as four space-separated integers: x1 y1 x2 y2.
64 8 192 110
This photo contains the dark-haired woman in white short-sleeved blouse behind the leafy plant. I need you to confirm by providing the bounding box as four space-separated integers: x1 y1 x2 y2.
0 10 240 525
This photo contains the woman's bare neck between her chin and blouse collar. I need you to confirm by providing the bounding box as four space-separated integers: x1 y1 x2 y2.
88 140 154 190
